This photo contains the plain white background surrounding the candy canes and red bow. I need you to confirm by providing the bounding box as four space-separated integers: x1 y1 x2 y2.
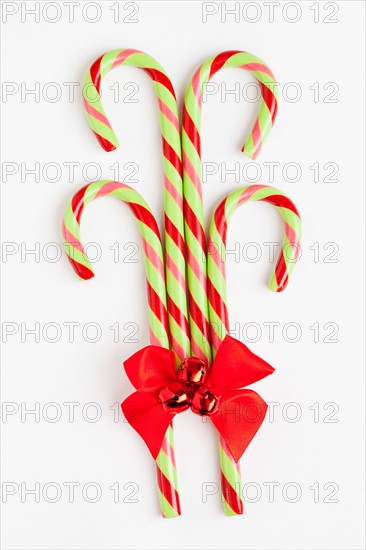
2 2 365 550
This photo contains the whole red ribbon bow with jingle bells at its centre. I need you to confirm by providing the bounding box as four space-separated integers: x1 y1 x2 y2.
121 336 274 462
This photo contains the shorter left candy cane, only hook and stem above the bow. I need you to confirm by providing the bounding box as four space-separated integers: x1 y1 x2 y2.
62 180 169 347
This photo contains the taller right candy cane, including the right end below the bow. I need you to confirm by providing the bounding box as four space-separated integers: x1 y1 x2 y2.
182 51 277 515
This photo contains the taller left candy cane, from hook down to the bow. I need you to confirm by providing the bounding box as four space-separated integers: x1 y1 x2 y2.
83 49 190 364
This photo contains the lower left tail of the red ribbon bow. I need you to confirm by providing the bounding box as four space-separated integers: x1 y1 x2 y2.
121 391 175 460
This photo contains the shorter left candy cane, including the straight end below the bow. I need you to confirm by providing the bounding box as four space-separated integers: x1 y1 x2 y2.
62 180 180 517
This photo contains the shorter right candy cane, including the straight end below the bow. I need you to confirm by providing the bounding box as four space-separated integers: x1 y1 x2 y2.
208 185 301 515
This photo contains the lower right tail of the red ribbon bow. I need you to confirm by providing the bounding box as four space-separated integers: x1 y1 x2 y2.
210 390 268 462
